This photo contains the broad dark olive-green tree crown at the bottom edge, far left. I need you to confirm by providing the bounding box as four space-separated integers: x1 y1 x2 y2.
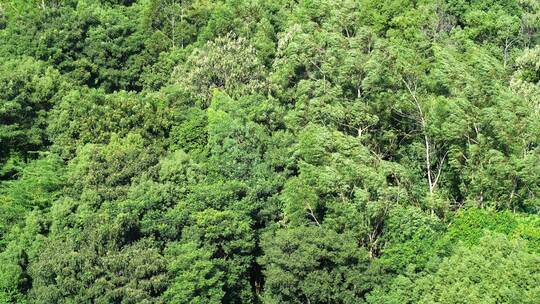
29 238 166 303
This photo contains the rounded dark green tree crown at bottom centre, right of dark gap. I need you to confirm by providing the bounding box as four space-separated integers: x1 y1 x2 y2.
260 226 374 303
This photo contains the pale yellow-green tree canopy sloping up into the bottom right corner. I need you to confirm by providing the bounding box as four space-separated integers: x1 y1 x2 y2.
368 234 539 303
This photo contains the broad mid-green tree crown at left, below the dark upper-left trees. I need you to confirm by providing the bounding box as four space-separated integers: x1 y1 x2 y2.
47 89 175 158
